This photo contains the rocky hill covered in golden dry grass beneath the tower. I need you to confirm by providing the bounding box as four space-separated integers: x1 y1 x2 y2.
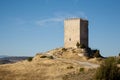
0 48 99 80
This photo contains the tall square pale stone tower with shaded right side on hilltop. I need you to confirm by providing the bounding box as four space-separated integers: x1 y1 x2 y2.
64 18 88 48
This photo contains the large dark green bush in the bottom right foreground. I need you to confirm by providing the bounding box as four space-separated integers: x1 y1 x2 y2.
94 57 120 80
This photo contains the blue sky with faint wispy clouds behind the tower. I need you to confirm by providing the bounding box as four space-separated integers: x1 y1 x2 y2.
0 0 120 56
